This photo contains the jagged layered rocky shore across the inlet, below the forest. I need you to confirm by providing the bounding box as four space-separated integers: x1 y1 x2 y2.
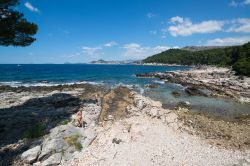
136 67 250 104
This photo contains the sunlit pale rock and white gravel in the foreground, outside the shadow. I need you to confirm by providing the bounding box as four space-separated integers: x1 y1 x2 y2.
20 92 250 166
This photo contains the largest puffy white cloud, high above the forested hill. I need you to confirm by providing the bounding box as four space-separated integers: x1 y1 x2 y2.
166 16 224 37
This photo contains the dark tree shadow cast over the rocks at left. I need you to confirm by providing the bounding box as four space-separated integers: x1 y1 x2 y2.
0 93 85 166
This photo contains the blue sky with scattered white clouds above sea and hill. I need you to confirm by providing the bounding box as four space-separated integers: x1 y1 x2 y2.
0 0 250 64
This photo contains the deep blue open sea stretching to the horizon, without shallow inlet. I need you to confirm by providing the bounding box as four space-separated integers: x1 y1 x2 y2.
0 64 189 86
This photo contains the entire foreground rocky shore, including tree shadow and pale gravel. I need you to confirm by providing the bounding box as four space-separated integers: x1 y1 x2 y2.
0 84 250 166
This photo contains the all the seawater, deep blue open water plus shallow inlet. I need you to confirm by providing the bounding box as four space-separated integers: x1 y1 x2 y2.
0 64 250 119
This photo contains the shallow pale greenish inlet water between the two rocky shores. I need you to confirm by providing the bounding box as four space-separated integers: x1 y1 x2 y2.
145 80 250 119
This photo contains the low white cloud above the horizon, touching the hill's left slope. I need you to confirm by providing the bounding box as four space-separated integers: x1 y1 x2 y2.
123 43 170 59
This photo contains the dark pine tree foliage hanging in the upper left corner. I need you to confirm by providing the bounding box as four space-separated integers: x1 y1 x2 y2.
0 0 38 47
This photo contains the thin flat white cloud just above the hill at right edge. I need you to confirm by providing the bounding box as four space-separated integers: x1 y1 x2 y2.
206 36 250 46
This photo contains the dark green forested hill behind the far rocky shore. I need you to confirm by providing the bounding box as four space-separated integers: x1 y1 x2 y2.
143 42 250 76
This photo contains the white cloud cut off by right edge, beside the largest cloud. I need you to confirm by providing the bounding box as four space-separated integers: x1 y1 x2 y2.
227 18 250 33
